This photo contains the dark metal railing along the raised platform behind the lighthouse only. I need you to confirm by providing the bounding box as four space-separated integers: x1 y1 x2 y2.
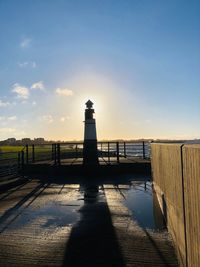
20 141 150 166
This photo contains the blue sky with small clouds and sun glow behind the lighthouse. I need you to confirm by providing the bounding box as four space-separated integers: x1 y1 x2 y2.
0 0 200 140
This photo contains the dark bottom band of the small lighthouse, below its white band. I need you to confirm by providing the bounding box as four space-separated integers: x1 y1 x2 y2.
83 140 99 166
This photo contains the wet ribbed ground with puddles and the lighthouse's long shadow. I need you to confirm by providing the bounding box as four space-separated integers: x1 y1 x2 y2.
0 178 177 267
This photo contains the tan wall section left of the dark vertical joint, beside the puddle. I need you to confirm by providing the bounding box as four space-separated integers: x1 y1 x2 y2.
151 144 186 266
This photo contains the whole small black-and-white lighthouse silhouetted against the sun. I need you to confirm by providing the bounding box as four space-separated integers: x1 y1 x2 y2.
83 100 99 165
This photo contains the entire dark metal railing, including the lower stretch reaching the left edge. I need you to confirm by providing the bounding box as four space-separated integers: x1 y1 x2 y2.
0 141 150 176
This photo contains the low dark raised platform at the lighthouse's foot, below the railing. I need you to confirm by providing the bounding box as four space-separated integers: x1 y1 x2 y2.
23 157 151 174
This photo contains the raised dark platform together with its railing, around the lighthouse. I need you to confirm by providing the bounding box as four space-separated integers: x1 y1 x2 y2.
18 141 151 175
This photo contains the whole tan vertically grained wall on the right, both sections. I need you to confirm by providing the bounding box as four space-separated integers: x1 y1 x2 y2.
151 143 200 267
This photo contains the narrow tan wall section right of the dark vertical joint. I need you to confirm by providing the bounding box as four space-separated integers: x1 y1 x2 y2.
183 145 200 267
